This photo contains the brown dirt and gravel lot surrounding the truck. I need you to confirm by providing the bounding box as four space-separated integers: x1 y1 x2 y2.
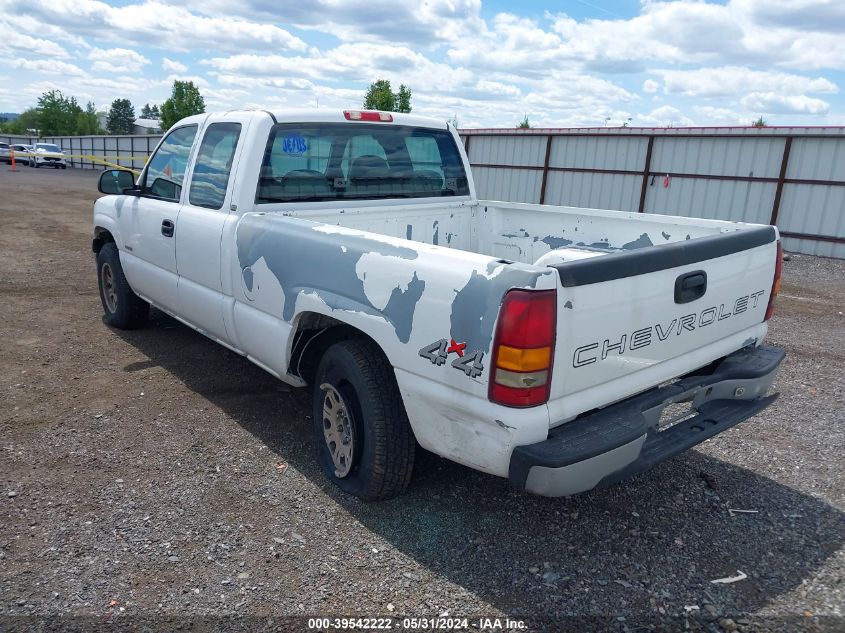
0 166 845 631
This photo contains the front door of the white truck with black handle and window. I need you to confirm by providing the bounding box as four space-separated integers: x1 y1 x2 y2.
117 125 197 312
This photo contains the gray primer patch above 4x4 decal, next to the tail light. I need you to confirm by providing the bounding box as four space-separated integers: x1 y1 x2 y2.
450 261 540 352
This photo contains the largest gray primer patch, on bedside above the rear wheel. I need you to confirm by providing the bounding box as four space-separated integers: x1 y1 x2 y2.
237 215 425 343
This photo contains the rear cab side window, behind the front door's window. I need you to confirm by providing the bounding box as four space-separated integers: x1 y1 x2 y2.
188 123 241 209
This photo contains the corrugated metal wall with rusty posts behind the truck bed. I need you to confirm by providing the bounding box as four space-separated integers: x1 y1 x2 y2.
461 127 845 258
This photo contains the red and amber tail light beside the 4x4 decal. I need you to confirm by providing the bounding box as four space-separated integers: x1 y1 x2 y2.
489 290 557 407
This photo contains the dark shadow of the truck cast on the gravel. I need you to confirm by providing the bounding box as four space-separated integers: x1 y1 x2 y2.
117 312 845 629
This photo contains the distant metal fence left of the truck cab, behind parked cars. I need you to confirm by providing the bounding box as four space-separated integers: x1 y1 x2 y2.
0 134 161 170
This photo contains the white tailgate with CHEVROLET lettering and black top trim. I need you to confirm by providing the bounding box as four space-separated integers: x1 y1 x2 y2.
549 226 777 425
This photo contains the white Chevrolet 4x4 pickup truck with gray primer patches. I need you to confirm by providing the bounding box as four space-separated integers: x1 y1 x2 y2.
93 111 784 500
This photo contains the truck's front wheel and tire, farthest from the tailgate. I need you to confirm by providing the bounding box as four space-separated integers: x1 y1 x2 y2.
97 242 150 330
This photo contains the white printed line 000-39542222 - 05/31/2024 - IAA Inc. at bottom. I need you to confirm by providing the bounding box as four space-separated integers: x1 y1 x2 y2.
308 617 528 631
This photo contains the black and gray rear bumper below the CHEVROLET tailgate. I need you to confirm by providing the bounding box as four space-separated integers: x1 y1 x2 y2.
508 346 785 497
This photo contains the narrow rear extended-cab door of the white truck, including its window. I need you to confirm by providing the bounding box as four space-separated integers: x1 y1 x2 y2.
176 115 251 342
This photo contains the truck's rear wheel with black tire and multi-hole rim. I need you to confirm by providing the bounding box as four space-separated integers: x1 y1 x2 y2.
313 340 416 501
